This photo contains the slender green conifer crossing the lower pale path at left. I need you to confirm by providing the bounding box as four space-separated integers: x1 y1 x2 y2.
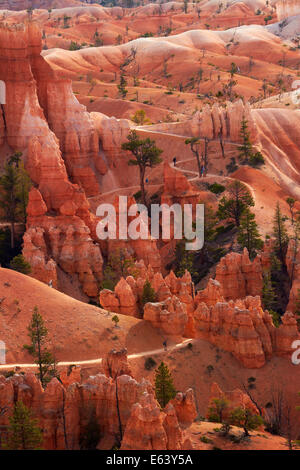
24 307 56 387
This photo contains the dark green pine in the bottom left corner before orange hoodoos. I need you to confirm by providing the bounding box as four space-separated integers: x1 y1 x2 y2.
3 401 43 450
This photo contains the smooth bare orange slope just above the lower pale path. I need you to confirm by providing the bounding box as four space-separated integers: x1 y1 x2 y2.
0 268 163 363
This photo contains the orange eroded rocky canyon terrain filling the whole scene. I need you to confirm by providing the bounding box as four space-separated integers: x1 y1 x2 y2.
0 0 300 450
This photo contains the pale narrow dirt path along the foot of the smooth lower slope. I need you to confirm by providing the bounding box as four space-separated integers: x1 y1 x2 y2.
0 339 195 370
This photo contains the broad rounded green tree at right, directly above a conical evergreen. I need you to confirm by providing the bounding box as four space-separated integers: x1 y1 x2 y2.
217 180 254 227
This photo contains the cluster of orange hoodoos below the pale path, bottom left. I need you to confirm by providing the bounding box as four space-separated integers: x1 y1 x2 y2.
0 350 195 450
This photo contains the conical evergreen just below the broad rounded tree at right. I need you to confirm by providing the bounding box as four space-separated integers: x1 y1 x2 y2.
237 208 264 259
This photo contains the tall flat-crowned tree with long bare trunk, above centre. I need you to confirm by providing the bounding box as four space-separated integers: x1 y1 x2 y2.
122 130 163 205
